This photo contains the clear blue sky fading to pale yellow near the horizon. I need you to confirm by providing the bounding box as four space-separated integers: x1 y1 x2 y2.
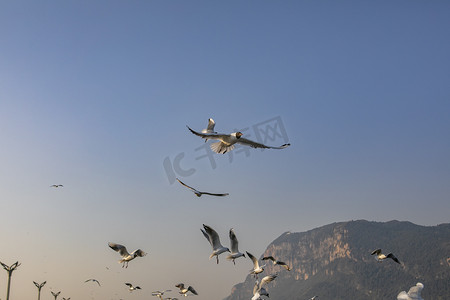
0 0 450 300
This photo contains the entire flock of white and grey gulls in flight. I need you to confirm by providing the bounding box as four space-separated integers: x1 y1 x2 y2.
44 119 423 300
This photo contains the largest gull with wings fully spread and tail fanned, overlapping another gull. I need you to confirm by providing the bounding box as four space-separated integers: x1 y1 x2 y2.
187 126 291 154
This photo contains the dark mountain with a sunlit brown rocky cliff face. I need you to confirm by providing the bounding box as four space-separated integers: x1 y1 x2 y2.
224 220 450 300
